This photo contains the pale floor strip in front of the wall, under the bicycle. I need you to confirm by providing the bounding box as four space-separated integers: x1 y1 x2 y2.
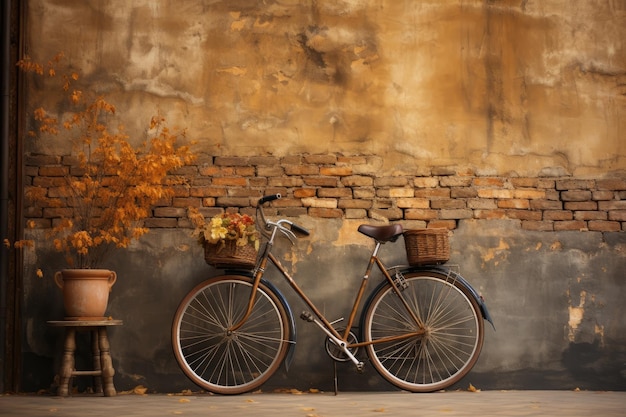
0 391 626 417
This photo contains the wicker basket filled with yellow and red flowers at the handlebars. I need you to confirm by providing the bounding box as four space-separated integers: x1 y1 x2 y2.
192 213 260 268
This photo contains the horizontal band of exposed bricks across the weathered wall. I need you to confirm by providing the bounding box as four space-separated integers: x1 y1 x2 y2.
25 154 626 232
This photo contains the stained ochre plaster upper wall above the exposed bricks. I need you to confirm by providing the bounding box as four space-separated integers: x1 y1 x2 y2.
26 0 626 176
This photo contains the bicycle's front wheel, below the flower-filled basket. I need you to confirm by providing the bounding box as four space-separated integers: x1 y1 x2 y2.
172 276 290 394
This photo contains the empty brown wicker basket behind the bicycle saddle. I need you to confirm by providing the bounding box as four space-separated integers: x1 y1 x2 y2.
403 229 450 266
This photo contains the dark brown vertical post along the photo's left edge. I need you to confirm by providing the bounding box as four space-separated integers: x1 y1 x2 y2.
0 0 26 392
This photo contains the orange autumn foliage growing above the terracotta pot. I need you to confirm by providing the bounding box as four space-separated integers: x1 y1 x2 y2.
18 55 195 268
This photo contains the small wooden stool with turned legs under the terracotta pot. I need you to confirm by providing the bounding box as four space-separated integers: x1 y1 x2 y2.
48 320 122 397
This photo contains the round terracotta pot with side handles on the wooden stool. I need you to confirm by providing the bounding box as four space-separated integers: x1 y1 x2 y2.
54 269 117 320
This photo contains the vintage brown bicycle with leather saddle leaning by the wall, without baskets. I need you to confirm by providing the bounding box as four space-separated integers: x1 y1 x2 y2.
172 194 493 394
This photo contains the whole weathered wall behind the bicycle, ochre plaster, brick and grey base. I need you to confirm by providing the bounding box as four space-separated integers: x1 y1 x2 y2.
22 0 626 391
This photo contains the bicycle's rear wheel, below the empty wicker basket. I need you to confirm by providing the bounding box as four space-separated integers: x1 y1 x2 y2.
364 271 484 392
